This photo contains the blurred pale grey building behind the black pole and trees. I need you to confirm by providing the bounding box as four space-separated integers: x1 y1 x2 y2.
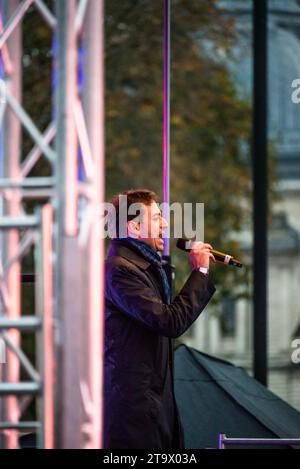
185 0 300 409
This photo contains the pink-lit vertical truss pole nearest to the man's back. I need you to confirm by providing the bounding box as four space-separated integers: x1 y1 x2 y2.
84 0 105 448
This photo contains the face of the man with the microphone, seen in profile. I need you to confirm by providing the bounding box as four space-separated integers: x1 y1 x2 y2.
132 202 168 251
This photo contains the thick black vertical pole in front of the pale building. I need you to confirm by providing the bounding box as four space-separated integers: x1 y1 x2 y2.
253 0 268 385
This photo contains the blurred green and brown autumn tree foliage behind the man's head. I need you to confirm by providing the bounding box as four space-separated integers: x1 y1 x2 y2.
106 0 251 295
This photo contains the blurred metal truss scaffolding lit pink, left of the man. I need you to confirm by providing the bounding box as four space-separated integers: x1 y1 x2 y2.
0 0 104 448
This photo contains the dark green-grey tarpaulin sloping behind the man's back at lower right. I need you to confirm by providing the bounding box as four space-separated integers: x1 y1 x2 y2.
174 345 300 449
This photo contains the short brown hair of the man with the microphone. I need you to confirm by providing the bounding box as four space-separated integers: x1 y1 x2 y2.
110 189 158 236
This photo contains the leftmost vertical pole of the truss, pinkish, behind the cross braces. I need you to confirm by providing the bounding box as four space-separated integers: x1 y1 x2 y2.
4 0 22 448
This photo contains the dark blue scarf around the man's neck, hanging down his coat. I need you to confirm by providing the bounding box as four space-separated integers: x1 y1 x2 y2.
122 238 171 304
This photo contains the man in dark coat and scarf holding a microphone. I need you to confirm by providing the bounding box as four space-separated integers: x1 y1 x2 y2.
104 189 215 450
